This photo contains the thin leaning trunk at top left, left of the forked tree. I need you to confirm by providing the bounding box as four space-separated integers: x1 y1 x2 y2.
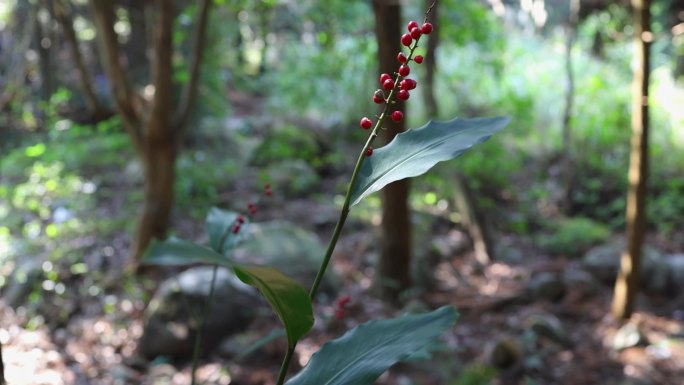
53 0 105 118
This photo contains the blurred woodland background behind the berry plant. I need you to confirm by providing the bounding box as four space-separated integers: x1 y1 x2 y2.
0 0 684 385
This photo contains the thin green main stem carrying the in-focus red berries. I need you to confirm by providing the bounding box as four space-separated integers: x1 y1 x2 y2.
276 32 432 385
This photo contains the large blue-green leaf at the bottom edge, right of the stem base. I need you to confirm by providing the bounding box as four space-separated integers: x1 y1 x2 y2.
286 306 457 385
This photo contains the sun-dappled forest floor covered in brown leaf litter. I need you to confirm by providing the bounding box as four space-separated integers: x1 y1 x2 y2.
0 94 684 385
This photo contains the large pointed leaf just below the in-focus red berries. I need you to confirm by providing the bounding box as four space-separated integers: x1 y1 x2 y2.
351 117 510 206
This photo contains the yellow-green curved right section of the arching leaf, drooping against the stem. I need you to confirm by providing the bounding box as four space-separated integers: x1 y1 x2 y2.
233 265 314 347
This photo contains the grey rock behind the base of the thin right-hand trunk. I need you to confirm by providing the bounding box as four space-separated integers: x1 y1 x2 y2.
582 240 669 294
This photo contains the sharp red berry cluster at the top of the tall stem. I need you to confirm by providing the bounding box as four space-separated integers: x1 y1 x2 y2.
359 21 433 156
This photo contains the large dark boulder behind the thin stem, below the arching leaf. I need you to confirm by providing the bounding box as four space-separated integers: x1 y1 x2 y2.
138 266 260 358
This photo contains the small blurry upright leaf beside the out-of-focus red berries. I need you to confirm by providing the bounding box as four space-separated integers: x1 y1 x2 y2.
204 207 248 255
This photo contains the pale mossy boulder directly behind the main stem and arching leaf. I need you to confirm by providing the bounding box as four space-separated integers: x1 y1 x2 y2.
234 221 336 293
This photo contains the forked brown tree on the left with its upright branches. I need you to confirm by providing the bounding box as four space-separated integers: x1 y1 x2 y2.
91 0 211 270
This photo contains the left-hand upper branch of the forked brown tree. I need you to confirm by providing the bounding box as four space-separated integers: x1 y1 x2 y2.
90 0 143 146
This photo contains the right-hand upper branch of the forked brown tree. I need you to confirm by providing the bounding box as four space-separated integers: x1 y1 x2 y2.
174 0 212 138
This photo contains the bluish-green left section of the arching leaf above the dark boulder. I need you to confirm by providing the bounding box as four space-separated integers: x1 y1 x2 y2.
142 237 231 266
